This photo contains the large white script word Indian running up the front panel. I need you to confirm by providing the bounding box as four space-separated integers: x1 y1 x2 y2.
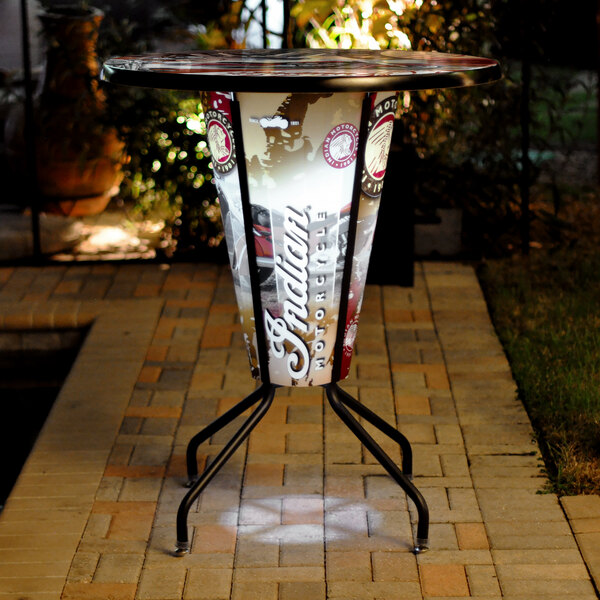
264 206 310 379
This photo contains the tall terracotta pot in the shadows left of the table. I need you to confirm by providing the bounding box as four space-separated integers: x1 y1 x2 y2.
7 6 126 216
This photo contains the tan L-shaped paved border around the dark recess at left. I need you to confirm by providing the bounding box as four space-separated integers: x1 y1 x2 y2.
0 299 164 597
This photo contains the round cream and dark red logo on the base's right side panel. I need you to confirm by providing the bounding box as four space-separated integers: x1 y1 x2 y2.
361 96 398 198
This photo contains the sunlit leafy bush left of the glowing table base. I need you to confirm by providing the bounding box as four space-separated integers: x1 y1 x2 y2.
92 4 223 256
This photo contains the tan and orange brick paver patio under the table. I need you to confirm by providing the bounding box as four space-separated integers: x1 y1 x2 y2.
0 263 600 600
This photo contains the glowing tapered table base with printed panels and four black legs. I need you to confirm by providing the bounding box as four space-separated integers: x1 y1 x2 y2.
176 86 429 556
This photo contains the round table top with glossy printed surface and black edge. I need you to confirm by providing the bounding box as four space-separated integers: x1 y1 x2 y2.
101 48 501 92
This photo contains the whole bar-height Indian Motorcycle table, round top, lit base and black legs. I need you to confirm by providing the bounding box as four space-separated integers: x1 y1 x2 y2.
102 49 500 556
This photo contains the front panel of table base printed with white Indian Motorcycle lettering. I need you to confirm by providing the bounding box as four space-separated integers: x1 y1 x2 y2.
237 93 364 386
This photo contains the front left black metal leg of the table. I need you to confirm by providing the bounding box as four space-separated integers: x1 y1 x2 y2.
175 384 276 556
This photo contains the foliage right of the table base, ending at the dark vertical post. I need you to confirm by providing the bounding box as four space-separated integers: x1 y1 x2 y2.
292 0 520 254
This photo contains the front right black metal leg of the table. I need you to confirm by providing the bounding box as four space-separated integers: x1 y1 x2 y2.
323 383 429 554
